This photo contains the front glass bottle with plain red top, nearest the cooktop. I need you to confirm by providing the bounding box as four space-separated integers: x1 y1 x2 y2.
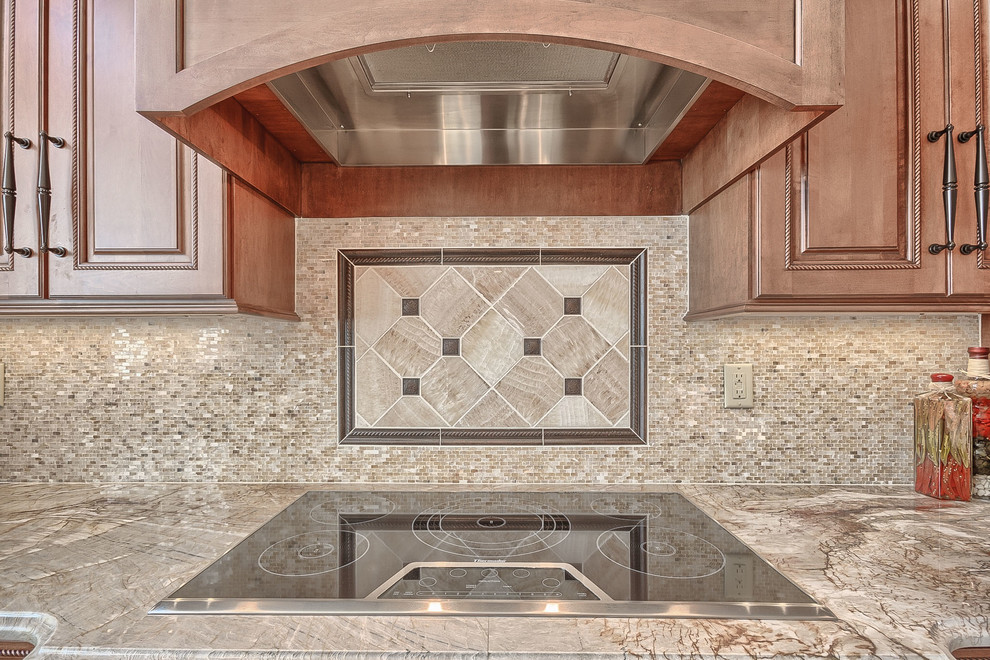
914 374 973 501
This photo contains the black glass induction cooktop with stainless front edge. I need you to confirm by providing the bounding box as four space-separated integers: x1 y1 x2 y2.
151 491 835 619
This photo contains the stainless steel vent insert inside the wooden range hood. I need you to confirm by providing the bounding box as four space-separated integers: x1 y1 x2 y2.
269 42 708 166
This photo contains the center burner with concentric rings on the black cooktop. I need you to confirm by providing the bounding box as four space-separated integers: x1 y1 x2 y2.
412 497 570 559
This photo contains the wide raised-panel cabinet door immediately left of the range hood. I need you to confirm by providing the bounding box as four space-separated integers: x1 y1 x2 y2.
47 0 225 298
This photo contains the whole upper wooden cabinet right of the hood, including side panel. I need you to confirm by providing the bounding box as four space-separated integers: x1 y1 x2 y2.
688 0 990 318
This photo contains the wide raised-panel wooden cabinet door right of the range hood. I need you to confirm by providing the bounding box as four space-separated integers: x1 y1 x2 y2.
756 0 947 302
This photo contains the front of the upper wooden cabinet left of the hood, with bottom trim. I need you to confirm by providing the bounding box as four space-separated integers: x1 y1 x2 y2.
0 0 236 314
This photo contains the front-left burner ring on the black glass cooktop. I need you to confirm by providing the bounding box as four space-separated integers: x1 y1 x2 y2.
257 528 371 577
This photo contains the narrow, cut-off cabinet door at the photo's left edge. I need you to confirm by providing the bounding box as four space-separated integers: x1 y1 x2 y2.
0 0 42 305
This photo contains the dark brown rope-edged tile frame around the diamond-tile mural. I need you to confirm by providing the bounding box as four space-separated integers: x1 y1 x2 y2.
337 248 647 446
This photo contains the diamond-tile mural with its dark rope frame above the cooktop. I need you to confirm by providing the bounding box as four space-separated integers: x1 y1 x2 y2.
337 248 647 445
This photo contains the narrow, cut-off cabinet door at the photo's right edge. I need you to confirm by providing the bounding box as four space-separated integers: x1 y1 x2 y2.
947 0 990 296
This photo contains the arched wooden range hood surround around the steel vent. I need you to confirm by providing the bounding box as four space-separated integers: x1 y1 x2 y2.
136 0 844 217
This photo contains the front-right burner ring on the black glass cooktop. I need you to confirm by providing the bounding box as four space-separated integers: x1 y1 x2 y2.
595 527 726 580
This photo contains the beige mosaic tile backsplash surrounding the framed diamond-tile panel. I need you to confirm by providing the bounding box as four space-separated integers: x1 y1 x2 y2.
0 217 979 484
